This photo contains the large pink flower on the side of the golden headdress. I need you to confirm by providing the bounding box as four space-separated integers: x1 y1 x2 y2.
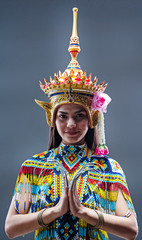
91 92 111 113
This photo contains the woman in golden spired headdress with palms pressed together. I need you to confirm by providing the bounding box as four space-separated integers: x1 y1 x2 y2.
5 9 138 240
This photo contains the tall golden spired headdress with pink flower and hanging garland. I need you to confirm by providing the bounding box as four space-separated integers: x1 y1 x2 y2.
35 8 111 155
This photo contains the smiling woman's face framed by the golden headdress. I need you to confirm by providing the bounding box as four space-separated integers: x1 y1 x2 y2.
55 103 89 145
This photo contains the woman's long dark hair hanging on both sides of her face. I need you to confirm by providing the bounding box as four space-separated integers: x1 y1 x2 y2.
48 126 99 150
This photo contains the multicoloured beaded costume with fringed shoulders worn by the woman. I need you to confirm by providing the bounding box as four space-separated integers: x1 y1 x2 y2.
15 144 133 240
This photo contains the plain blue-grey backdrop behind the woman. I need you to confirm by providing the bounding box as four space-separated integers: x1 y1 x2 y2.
0 0 142 240
